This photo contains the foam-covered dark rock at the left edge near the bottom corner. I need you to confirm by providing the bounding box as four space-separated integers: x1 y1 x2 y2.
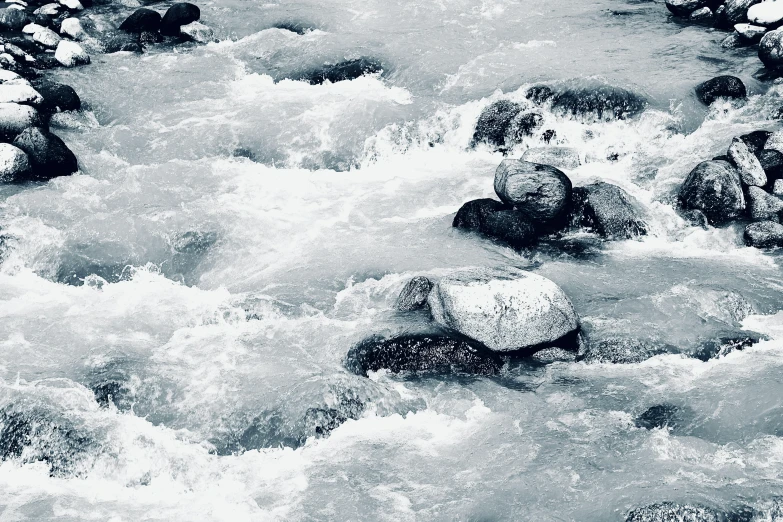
0 405 94 477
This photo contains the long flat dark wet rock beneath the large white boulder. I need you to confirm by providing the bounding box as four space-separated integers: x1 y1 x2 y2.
345 334 503 375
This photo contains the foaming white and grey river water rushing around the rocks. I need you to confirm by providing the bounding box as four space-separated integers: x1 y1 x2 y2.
0 0 783 522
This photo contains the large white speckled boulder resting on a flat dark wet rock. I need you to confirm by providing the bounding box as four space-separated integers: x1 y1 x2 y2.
427 269 579 352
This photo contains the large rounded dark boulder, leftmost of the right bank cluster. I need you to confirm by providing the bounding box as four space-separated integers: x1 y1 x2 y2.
678 161 745 225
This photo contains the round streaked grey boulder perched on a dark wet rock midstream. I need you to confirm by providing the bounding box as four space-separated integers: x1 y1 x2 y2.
495 160 571 225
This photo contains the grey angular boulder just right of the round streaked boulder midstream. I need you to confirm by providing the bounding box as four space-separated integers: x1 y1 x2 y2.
570 181 649 239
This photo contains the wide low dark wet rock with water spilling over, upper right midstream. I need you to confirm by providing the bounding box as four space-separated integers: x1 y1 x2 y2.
552 85 647 121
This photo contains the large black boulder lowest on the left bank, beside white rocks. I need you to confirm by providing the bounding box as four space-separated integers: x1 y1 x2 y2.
14 127 79 181
